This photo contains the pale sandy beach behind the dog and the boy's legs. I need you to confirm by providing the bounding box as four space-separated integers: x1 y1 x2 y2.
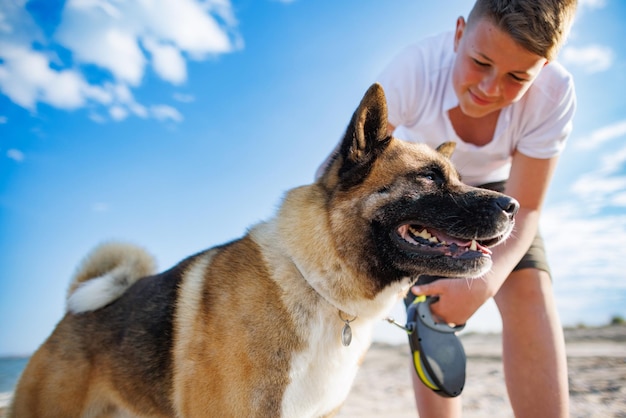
0 325 626 418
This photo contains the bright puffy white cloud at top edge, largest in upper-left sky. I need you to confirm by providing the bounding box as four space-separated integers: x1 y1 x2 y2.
56 0 234 86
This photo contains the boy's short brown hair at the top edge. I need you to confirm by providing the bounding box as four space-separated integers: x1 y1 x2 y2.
467 0 577 60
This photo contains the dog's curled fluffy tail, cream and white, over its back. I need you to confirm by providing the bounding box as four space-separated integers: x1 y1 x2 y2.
67 243 155 313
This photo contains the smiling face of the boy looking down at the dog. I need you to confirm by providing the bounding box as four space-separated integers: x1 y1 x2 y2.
452 18 548 118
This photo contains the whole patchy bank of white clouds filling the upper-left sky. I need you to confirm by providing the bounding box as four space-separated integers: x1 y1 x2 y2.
0 0 241 121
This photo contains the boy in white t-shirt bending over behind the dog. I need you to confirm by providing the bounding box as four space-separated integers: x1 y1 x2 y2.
378 0 576 418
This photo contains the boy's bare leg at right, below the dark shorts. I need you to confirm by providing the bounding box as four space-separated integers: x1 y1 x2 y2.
495 268 569 418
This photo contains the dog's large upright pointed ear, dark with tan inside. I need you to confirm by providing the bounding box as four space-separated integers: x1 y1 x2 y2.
338 83 391 188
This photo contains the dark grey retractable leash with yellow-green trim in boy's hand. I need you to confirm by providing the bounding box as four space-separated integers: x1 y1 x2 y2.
387 296 467 398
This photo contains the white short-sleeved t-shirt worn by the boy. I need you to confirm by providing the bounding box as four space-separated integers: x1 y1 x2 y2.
378 32 576 186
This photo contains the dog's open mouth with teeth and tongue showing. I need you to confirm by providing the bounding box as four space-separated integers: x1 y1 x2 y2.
396 224 492 259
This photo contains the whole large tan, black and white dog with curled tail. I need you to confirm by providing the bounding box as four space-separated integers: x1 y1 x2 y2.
9 84 517 418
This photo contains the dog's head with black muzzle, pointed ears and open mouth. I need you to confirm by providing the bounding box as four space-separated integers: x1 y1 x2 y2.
318 84 519 289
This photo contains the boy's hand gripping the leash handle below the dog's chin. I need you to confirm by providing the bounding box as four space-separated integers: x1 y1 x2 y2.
411 277 491 325
